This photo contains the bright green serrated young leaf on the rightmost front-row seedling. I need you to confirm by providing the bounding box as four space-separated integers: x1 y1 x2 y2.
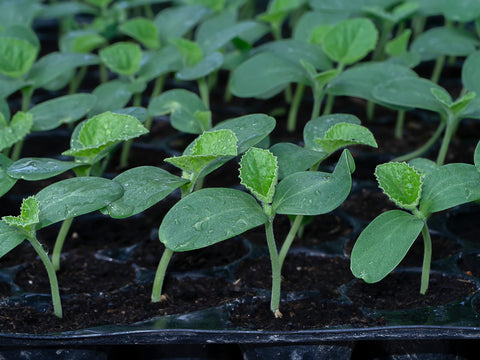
375 162 423 210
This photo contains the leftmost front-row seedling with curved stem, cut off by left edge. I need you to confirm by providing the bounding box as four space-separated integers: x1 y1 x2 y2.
0 177 123 318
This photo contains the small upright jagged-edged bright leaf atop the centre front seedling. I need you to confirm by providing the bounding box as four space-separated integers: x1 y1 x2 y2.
240 148 278 204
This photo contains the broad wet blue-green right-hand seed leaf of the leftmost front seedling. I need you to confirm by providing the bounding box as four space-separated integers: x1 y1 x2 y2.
36 176 123 228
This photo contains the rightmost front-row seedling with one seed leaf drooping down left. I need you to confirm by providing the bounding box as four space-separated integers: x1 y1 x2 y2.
351 162 480 294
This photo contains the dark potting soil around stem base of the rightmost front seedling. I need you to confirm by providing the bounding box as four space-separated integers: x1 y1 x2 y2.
346 272 478 310
